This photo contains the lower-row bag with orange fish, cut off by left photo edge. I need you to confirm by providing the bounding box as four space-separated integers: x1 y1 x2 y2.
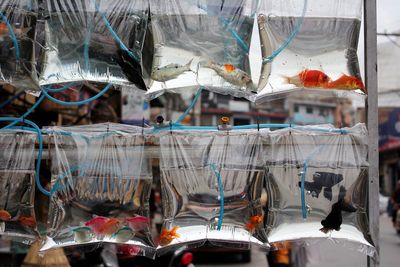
0 130 39 244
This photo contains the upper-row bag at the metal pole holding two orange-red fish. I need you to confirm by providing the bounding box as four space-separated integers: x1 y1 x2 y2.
257 0 366 99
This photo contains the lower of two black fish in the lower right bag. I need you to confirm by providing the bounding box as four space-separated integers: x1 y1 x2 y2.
319 198 357 234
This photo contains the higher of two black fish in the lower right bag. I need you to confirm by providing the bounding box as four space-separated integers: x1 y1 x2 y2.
299 172 343 201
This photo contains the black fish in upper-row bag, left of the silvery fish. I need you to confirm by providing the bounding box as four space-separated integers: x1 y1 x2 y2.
117 49 147 91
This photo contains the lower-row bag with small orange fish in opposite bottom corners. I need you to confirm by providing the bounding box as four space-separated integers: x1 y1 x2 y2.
157 132 268 254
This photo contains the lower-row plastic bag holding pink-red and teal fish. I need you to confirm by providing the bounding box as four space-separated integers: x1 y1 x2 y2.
42 123 155 258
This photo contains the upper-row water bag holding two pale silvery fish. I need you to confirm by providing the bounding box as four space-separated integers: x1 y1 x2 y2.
148 0 257 100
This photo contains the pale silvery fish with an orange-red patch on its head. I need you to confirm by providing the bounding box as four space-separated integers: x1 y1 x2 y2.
204 61 253 89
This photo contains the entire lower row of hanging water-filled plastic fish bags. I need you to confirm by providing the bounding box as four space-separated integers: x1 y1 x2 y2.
0 124 375 257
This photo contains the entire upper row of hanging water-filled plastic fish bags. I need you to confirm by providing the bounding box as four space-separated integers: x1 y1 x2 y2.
0 0 366 101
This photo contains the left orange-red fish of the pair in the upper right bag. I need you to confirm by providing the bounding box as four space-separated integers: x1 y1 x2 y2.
285 70 330 88
